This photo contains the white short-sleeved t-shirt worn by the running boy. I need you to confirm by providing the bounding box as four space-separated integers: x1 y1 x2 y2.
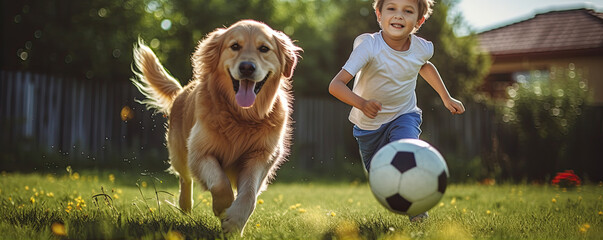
343 31 433 130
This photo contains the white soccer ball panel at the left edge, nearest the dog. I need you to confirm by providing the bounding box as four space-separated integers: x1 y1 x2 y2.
369 165 400 202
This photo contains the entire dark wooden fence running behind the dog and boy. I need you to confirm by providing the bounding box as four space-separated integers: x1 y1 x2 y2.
0 71 493 170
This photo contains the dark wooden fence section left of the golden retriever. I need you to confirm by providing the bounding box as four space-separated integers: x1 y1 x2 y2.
0 71 167 166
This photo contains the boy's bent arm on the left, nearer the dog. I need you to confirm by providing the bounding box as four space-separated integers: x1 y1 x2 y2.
329 69 381 118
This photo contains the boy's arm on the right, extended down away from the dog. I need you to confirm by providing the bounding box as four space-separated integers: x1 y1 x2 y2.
419 61 465 114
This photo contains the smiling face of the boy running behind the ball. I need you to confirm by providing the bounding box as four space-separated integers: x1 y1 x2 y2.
376 0 425 38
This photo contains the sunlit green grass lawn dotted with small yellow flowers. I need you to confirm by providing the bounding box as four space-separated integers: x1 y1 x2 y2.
0 172 603 239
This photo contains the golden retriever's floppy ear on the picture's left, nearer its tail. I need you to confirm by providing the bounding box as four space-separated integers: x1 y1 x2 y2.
191 28 226 79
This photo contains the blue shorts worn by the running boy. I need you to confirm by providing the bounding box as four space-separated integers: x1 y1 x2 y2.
354 112 423 172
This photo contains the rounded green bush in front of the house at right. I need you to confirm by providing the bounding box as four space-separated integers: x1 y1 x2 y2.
499 68 589 180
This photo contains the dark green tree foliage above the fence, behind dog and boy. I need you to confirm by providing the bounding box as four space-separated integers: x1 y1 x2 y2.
2 0 487 98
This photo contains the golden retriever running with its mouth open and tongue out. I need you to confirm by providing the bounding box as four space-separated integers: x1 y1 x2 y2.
132 20 302 235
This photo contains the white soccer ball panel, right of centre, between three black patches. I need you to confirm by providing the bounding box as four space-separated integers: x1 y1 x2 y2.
400 167 438 203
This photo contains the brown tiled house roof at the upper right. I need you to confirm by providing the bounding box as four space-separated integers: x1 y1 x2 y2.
478 9 603 56
